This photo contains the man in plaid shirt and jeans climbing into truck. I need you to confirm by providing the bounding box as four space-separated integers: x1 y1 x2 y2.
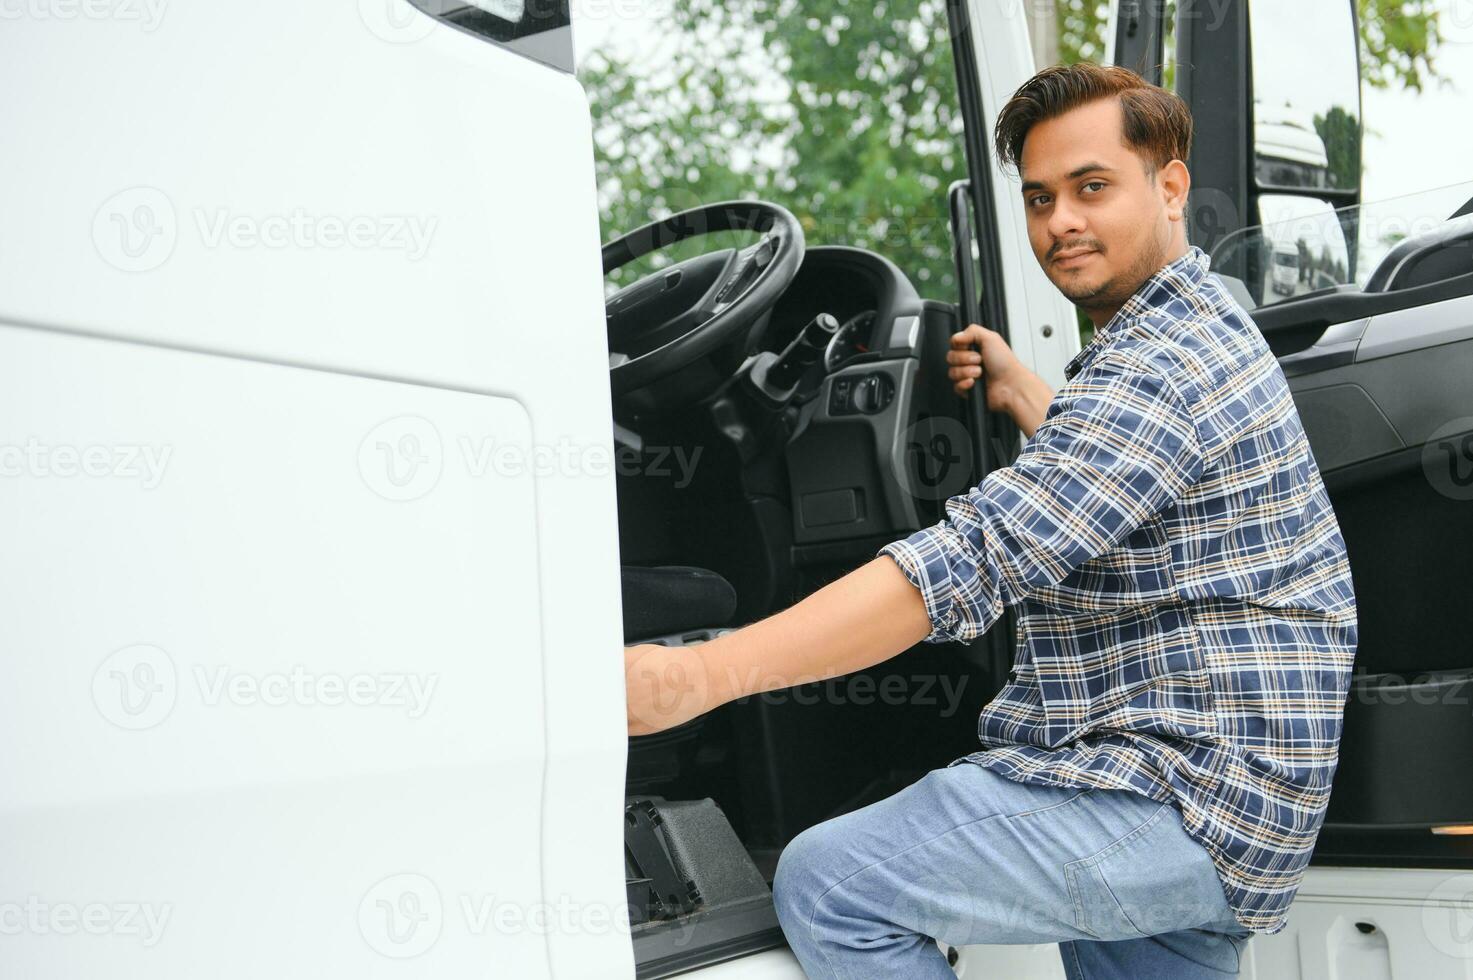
626 63 1357 980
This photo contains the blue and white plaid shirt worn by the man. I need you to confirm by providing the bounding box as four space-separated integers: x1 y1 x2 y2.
879 246 1357 934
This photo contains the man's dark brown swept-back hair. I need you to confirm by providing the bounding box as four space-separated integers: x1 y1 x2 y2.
993 62 1192 174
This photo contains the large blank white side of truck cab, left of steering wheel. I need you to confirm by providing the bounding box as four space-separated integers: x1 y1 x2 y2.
0 0 632 979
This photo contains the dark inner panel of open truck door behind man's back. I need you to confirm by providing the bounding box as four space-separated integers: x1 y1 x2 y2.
1290 316 1473 676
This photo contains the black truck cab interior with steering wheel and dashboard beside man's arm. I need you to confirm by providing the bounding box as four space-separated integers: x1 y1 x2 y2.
604 200 987 976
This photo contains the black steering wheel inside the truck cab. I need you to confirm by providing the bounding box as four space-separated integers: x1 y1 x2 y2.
604 200 803 396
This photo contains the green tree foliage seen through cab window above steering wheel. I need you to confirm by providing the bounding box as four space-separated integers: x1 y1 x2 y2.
579 0 966 299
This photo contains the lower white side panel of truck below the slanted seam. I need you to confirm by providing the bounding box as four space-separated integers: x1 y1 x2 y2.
0 326 549 980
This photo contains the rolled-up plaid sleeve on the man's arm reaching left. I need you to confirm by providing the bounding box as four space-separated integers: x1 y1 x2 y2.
876 352 1203 643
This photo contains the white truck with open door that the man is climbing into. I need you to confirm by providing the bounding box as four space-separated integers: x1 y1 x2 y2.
0 0 1473 980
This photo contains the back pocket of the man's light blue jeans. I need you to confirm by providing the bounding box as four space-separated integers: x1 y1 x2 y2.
1064 803 1231 942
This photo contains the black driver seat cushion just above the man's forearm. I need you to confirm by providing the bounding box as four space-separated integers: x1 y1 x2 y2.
619 564 737 643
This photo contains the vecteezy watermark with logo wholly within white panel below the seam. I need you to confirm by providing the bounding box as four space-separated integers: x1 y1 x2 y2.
91 644 440 731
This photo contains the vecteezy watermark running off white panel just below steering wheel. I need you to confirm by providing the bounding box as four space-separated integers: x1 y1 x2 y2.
358 416 704 501
